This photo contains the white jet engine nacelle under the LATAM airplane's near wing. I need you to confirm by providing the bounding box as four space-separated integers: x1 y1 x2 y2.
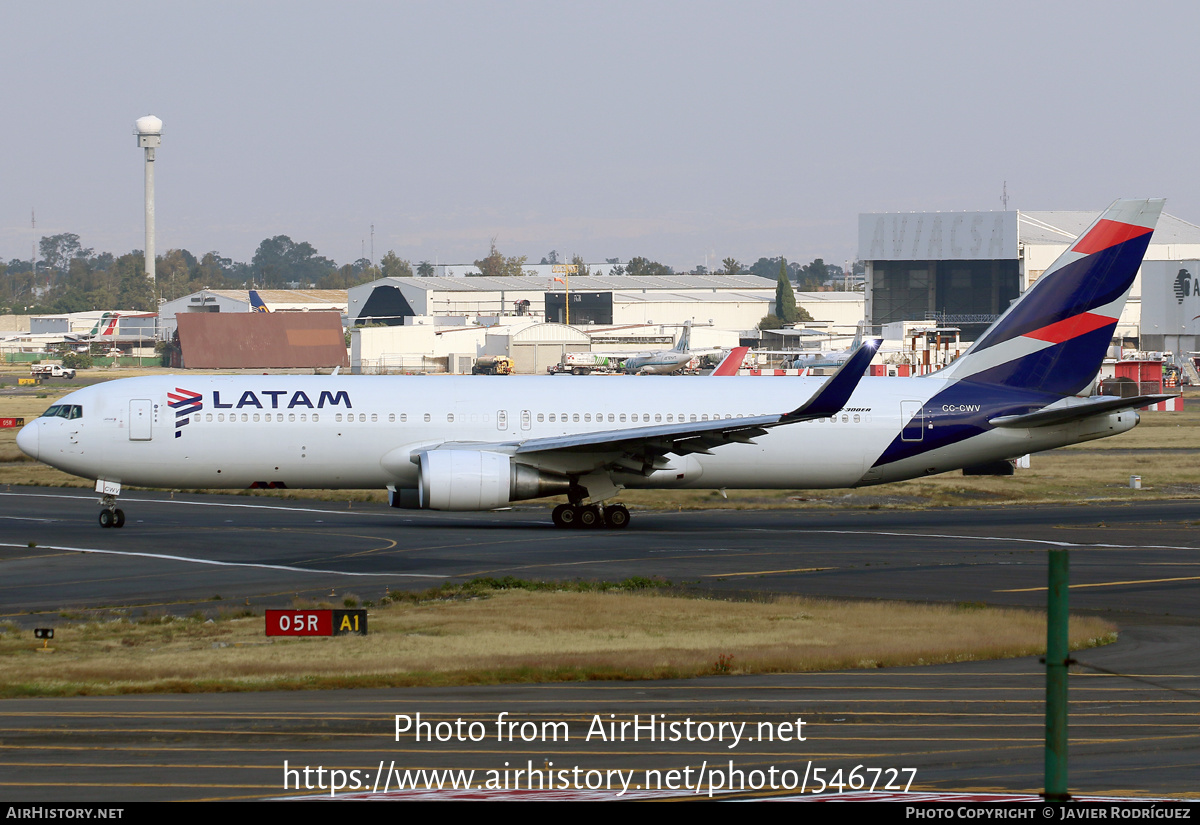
416 450 570 510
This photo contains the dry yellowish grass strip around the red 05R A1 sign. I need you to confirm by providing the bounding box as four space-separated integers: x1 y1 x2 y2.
0 590 1116 697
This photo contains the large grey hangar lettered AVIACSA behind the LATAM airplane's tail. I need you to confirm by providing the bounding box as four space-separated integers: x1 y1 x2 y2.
858 211 1200 353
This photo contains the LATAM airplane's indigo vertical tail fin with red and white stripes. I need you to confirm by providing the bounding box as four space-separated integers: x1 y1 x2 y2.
937 199 1163 396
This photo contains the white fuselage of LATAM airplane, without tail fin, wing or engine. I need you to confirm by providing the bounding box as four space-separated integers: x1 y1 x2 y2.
18 375 1138 496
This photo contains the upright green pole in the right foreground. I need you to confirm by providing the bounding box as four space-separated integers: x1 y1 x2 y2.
1045 550 1070 800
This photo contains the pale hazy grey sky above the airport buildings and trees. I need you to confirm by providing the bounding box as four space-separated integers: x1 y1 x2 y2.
0 0 1200 269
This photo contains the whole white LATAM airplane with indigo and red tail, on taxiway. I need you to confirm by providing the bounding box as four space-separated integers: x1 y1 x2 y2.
17 200 1163 528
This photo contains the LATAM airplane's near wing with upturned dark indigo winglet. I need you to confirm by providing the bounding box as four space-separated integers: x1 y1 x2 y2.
502 339 882 472
